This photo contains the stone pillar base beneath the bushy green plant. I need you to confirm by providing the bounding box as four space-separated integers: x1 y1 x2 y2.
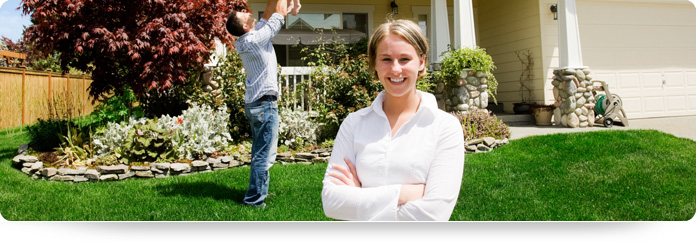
435 70 488 112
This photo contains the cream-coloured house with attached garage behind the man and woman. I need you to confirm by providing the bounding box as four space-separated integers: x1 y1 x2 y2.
235 0 696 118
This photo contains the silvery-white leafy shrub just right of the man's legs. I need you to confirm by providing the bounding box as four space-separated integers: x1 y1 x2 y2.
278 108 319 150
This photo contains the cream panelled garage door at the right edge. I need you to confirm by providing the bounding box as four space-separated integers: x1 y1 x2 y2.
577 0 696 119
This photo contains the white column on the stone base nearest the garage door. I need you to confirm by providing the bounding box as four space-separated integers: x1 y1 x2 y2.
558 0 584 68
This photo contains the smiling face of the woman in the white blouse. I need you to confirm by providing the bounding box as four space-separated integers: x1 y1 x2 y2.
375 34 425 97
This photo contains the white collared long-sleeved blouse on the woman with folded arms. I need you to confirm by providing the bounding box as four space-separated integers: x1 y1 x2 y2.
321 91 465 220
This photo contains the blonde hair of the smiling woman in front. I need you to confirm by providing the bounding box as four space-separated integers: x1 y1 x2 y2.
367 20 430 78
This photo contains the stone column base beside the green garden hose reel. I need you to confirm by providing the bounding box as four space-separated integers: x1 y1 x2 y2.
551 68 596 128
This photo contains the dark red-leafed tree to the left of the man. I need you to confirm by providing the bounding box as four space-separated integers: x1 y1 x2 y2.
21 0 248 99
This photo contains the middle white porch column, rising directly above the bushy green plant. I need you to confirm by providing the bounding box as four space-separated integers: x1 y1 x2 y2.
452 0 476 49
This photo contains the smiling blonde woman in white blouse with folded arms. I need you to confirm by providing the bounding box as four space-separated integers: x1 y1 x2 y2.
322 20 465 220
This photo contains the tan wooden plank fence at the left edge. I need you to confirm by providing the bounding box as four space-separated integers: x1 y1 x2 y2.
0 67 95 129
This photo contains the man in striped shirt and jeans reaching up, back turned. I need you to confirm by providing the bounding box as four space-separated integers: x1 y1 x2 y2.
226 0 288 207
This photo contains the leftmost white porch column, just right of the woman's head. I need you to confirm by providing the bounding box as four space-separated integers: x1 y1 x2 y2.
430 0 449 63
